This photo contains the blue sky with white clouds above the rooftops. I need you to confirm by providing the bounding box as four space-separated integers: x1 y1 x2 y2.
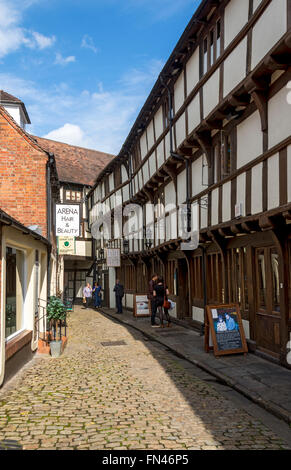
0 0 200 153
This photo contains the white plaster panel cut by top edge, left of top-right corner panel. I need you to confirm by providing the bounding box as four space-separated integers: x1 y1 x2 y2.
224 0 249 48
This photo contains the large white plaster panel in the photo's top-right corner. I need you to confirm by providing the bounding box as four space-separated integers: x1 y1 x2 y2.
252 0 287 69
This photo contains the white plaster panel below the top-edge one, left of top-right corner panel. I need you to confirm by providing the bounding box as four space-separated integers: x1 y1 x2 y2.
223 38 247 96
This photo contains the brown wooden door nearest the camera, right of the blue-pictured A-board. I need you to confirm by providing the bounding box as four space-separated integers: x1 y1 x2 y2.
254 247 281 358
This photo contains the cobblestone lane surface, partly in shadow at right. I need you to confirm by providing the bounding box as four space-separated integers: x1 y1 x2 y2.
0 307 287 450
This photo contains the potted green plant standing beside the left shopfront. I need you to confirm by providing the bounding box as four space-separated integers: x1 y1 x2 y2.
47 297 67 357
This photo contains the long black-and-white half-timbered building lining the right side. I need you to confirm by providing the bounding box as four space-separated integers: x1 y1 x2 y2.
89 0 291 365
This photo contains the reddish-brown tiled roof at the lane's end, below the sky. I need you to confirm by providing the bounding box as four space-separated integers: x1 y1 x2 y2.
32 136 114 186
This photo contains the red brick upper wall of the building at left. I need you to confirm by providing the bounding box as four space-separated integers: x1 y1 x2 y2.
0 114 47 237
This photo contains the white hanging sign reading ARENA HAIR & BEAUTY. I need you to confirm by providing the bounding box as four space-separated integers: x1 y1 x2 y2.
56 204 80 237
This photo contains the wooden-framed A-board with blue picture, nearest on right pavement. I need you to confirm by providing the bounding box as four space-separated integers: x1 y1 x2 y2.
205 304 248 356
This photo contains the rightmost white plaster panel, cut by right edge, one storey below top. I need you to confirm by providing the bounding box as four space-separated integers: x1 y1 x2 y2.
268 86 291 148
